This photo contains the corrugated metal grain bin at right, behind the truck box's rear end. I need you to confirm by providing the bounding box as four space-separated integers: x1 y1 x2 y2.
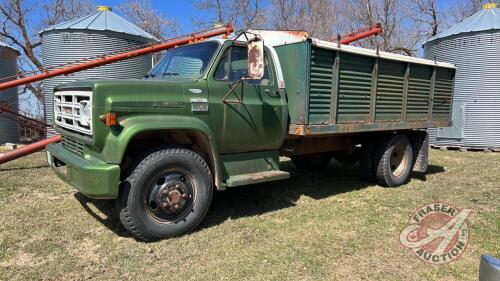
424 4 500 149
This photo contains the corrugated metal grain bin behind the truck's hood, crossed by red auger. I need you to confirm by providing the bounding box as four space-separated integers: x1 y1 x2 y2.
40 6 158 134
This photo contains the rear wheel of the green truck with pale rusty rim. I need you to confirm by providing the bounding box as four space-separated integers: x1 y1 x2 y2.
373 134 413 187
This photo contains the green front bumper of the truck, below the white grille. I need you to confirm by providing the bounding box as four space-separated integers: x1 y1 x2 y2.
47 144 120 199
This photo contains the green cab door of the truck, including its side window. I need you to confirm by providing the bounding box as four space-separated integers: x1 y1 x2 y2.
208 45 286 153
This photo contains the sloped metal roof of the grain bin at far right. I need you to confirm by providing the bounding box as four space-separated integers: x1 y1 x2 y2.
425 7 500 43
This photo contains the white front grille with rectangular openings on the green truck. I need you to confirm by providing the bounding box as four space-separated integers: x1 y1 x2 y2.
54 91 92 135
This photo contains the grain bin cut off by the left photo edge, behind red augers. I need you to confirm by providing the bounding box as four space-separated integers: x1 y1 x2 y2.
0 42 19 144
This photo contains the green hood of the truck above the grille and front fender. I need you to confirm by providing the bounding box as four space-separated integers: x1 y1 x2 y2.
54 79 188 112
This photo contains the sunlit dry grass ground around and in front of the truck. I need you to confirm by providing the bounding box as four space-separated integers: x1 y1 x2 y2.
0 150 500 280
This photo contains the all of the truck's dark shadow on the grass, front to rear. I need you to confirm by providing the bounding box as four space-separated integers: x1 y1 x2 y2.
75 161 445 237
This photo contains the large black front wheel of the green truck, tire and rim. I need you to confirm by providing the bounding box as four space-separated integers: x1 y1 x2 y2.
118 148 213 241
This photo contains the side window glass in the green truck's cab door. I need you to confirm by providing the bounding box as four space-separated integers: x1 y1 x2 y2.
214 46 272 83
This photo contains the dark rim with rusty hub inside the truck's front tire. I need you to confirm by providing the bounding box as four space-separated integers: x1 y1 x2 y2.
145 171 194 223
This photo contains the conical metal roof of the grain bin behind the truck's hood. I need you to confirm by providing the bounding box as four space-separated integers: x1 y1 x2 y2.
40 8 158 41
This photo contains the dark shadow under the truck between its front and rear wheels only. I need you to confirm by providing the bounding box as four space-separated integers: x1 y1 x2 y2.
199 161 372 229
